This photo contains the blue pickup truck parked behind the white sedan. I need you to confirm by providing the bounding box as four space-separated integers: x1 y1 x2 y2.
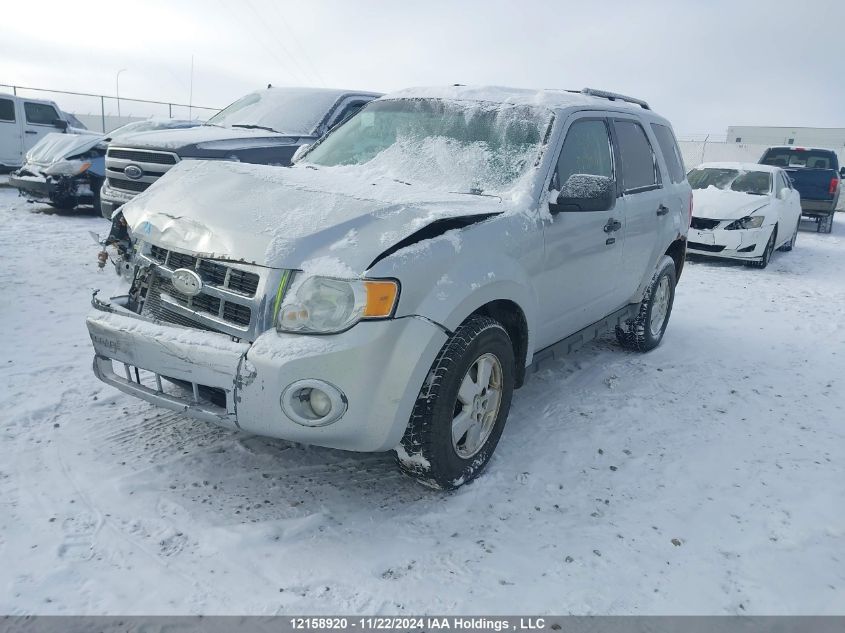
760 147 845 233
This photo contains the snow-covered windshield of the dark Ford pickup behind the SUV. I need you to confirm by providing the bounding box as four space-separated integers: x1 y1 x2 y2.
208 88 341 136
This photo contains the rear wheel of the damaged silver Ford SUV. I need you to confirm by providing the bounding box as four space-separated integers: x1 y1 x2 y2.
616 255 677 352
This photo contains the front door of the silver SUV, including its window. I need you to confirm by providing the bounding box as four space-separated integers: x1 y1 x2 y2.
537 112 625 348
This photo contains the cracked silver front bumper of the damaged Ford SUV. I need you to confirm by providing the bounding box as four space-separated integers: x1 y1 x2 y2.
87 301 447 451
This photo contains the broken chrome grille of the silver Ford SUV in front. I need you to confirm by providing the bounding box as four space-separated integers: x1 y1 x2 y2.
140 246 268 340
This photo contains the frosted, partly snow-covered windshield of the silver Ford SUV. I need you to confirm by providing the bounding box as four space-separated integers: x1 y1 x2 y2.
304 99 552 193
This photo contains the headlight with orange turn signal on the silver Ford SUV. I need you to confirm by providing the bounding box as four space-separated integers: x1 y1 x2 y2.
276 277 399 334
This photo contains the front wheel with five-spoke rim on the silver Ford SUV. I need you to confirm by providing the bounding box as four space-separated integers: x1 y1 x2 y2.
395 315 515 490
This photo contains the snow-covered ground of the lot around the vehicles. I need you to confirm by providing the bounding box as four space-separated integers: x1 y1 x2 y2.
0 189 845 614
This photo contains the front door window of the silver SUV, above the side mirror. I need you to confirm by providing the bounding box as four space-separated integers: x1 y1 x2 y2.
555 119 613 189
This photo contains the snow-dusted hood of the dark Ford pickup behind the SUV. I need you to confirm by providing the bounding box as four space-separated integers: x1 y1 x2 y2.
114 125 299 157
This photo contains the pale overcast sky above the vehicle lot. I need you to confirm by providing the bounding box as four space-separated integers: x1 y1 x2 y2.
0 0 845 135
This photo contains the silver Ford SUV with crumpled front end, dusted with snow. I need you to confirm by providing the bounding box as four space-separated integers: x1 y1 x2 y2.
87 86 691 488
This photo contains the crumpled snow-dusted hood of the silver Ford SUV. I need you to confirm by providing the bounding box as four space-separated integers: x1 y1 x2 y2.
121 161 505 276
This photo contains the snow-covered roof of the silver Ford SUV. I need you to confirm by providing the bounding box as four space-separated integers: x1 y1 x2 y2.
384 85 645 112
